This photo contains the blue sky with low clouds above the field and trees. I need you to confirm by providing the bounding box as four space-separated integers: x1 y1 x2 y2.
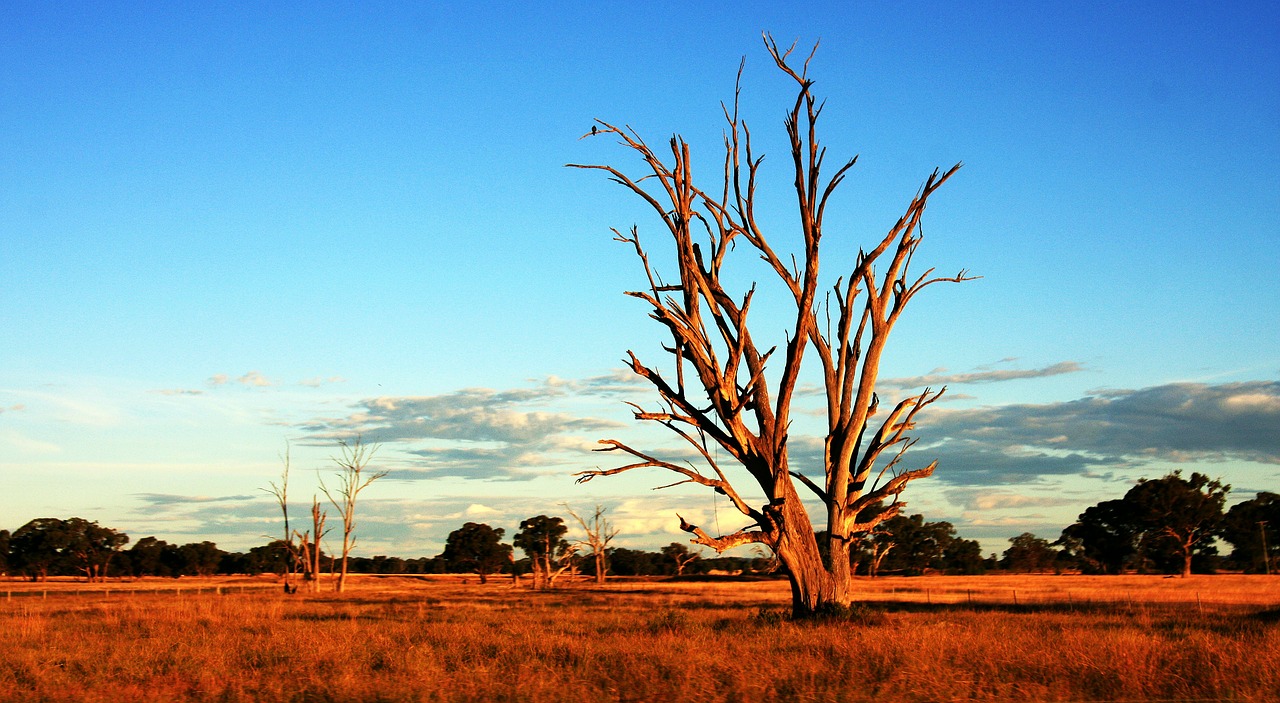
0 1 1280 556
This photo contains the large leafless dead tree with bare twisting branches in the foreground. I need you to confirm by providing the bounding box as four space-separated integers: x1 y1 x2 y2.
568 35 972 616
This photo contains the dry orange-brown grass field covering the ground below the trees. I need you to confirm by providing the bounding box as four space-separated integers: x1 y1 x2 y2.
0 576 1280 702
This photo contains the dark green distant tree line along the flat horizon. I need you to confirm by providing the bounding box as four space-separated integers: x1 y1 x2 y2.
0 471 1280 588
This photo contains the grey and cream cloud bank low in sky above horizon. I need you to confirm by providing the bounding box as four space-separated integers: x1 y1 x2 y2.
112 362 1280 552
